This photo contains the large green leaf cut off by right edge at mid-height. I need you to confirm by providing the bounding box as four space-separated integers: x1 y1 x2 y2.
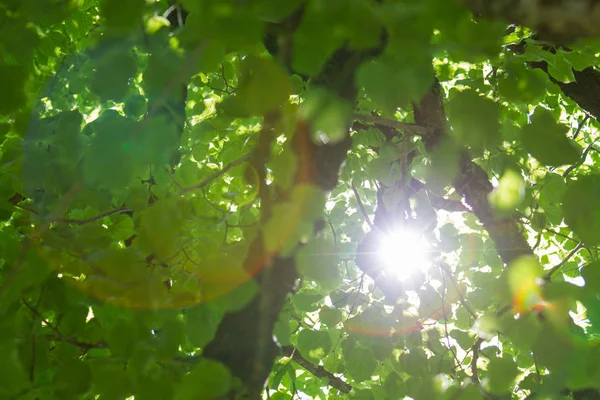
562 175 600 246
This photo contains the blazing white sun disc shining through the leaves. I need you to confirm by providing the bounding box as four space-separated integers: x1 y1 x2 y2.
379 231 431 281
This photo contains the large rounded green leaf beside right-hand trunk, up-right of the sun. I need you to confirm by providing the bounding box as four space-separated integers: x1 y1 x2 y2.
448 90 501 153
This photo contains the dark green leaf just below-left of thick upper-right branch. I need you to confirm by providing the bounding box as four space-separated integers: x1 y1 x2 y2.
521 107 581 167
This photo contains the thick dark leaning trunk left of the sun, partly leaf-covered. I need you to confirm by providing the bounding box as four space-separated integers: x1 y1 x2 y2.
203 12 383 398
